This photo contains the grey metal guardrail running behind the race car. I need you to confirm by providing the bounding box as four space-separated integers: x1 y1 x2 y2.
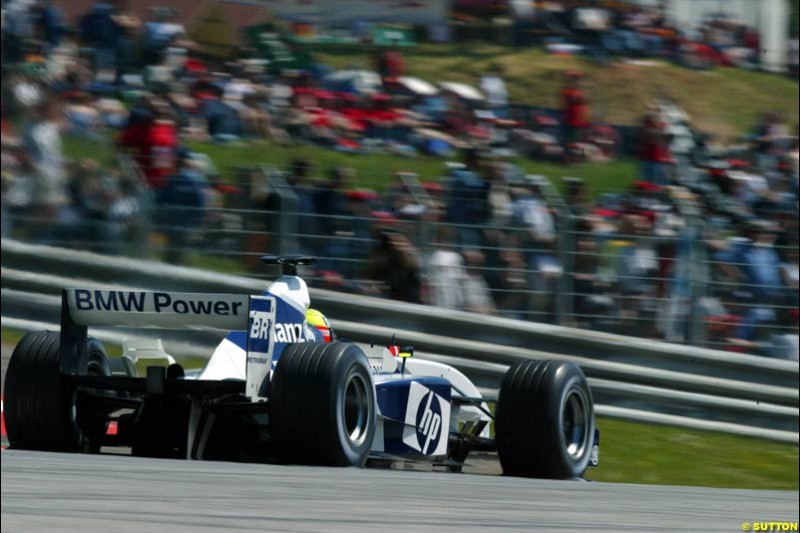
1 240 800 443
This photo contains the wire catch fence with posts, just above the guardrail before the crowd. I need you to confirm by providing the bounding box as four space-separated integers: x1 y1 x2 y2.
4 158 798 359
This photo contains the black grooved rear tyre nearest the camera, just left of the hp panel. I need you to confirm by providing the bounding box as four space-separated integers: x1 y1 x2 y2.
270 342 376 466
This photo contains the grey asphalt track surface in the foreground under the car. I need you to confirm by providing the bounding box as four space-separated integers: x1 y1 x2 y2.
0 450 798 533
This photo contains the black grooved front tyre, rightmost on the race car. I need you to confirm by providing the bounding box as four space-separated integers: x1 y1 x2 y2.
495 361 594 479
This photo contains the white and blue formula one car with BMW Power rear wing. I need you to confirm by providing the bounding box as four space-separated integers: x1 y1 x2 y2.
5 257 598 478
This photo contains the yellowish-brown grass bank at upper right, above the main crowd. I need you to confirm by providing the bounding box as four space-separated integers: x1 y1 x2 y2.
312 42 799 137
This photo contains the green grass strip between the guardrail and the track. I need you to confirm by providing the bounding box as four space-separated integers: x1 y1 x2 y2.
2 328 798 490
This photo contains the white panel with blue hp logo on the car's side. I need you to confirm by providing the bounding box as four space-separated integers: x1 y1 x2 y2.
403 382 450 455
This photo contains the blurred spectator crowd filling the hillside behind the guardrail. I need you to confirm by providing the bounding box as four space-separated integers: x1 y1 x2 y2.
2 0 798 359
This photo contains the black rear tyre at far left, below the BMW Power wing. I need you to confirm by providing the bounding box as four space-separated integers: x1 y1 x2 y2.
4 331 111 452
